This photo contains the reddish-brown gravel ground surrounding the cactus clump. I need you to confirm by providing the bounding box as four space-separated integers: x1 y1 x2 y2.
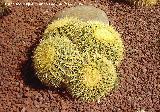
0 0 160 112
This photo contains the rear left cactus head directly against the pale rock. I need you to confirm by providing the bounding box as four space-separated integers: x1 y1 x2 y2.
43 17 87 39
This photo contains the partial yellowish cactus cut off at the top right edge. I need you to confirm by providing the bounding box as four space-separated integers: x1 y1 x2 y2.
128 0 158 6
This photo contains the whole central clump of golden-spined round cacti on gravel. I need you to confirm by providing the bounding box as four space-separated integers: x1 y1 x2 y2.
33 17 124 101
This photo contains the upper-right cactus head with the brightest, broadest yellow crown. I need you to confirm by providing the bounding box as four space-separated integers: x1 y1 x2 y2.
86 21 124 66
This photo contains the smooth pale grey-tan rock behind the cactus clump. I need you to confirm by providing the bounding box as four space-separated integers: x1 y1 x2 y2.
53 5 109 25
